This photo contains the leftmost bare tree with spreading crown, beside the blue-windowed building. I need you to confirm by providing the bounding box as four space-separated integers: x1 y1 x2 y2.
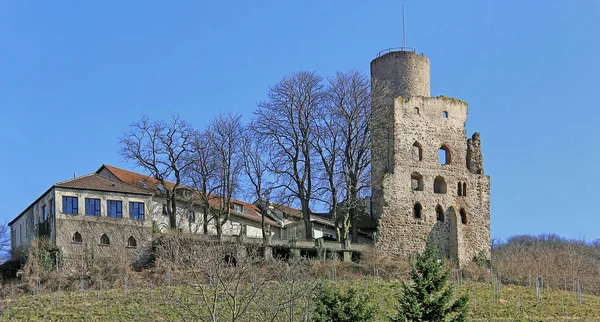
119 115 194 229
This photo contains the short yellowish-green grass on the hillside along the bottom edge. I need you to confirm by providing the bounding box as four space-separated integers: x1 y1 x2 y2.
1 279 600 321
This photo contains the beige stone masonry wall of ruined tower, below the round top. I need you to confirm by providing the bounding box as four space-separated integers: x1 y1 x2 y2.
372 97 490 264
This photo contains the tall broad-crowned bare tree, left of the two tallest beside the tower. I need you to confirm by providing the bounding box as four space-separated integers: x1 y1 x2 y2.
255 72 324 239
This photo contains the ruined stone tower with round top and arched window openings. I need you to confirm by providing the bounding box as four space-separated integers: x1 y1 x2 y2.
371 50 490 265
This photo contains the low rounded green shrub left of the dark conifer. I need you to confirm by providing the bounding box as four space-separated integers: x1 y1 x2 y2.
313 284 376 322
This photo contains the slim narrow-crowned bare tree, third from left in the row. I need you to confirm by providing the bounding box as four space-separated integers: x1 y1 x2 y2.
208 114 243 239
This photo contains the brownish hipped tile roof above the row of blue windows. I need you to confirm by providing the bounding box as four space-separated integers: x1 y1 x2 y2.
55 173 151 195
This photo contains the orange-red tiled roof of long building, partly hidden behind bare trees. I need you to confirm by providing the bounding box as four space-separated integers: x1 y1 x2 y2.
96 164 279 226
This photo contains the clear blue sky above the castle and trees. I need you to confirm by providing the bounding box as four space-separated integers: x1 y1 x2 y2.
0 0 600 240
